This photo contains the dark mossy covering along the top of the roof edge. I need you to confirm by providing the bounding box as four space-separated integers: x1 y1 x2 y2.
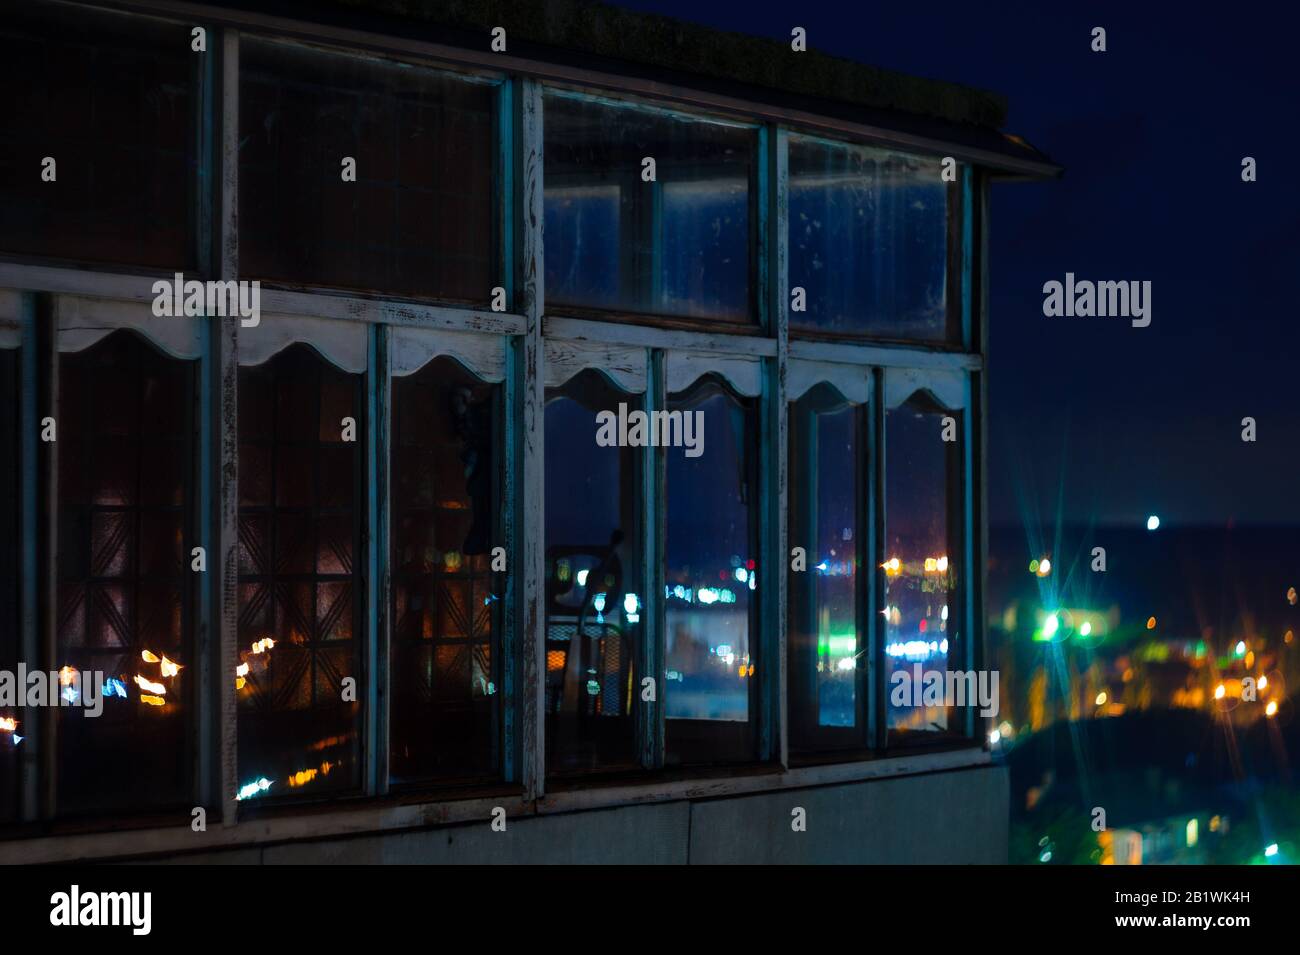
317 0 1006 129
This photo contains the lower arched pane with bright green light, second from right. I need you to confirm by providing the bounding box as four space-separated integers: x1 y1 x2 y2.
788 385 867 750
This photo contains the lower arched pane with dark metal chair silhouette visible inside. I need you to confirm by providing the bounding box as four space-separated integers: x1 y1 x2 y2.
546 372 645 772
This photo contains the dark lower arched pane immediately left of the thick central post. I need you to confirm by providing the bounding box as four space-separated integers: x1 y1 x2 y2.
390 357 506 783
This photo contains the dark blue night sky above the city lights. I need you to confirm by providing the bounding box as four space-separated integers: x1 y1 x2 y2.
618 0 1300 525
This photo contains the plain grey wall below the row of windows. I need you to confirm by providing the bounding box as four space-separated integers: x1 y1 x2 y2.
147 767 1008 865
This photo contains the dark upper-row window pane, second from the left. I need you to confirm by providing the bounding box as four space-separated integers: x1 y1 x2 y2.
239 40 498 304
